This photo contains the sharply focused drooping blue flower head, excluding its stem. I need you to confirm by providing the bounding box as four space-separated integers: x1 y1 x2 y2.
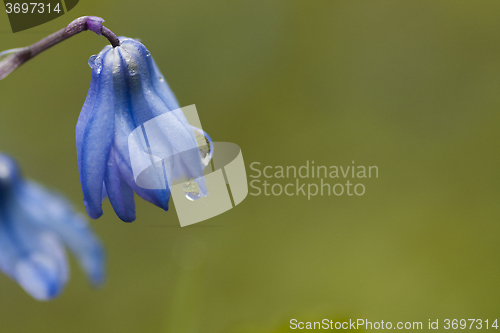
76 37 207 222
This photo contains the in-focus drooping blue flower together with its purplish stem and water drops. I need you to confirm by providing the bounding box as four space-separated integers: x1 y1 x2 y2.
0 16 209 222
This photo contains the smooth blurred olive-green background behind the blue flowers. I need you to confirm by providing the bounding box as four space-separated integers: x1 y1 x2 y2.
0 0 500 333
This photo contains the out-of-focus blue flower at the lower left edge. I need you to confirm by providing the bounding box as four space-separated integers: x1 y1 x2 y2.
0 154 104 300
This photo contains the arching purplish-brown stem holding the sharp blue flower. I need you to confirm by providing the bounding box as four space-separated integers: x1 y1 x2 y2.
0 16 120 80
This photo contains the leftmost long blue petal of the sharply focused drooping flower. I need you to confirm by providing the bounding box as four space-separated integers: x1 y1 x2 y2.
77 49 116 219
